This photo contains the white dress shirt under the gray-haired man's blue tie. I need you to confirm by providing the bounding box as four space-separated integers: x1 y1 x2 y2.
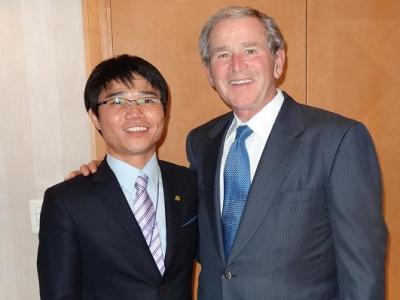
219 90 284 214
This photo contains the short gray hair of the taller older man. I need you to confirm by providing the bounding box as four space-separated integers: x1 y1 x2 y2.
199 6 286 66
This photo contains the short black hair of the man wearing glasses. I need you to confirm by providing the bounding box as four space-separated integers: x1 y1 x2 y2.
84 54 169 116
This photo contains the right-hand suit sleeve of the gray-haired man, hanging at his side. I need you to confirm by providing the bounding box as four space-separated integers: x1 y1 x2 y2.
328 123 387 300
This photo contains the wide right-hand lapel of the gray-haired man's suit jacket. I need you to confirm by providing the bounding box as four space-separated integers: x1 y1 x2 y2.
229 94 304 261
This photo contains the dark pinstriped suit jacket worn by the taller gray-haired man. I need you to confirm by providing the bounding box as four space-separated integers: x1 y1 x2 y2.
187 94 387 300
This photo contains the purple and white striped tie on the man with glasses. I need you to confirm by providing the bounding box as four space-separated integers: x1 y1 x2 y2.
133 173 165 275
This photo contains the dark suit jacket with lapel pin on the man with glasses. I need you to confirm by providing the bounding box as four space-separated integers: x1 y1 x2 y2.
38 161 198 300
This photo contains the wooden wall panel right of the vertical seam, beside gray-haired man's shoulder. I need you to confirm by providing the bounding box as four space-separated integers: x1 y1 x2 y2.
307 0 400 300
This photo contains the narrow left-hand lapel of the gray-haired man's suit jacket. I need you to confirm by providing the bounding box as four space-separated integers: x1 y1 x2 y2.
203 113 233 261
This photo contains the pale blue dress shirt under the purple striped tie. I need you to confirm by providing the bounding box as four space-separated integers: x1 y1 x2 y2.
107 153 167 257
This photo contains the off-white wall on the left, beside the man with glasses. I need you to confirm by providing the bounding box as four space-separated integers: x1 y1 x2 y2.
0 0 90 300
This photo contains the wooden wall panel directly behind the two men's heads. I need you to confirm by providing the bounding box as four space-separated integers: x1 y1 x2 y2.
106 0 306 164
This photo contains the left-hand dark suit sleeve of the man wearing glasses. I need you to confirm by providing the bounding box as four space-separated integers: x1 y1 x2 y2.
37 189 80 300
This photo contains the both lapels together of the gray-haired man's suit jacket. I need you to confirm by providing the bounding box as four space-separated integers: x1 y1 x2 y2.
202 92 305 261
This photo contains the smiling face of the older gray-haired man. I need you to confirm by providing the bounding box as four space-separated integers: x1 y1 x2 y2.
206 17 285 121
